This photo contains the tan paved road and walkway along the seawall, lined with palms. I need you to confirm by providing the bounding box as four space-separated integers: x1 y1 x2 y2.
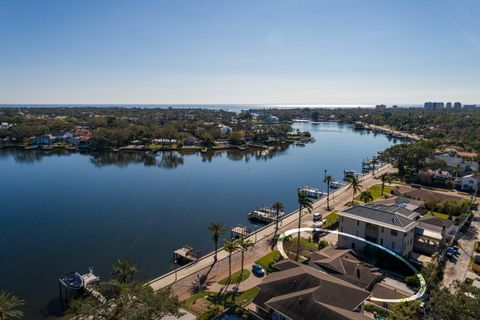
147 165 394 298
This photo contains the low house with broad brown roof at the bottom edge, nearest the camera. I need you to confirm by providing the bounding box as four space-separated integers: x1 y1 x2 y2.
253 261 371 320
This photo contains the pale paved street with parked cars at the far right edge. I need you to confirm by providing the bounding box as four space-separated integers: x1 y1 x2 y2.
443 211 480 289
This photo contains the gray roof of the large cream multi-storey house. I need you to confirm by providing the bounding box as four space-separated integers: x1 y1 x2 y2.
340 204 417 229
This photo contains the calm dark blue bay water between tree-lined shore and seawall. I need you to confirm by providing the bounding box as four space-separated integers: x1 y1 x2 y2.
0 123 395 319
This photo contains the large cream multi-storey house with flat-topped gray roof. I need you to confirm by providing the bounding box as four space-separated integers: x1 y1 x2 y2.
338 203 419 256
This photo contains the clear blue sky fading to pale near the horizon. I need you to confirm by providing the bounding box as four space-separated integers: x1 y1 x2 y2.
0 0 480 104
